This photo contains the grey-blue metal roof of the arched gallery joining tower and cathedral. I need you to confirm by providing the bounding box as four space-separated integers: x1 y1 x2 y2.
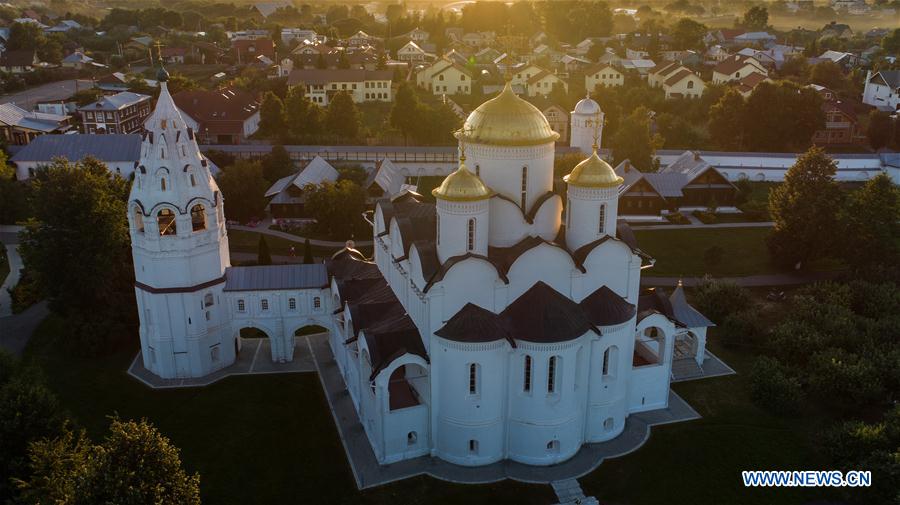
225 263 328 291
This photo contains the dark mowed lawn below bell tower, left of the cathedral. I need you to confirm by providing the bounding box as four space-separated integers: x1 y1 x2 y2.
25 316 555 505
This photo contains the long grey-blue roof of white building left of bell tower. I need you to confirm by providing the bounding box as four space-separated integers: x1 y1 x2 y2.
11 134 141 163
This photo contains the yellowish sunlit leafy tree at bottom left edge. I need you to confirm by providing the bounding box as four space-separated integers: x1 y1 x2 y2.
20 419 200 505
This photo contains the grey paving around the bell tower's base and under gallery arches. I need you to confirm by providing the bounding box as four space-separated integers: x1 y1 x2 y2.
128 333 316 389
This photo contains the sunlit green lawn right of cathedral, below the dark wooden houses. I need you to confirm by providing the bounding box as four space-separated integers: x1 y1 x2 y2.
634 228 778 276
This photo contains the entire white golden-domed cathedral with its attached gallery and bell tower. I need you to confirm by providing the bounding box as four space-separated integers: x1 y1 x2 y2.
129 70 712 466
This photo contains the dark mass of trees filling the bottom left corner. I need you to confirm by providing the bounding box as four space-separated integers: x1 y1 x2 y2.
0 351 200 504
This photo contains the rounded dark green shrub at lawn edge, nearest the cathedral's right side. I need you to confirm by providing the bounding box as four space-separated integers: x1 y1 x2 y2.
750 356 803 415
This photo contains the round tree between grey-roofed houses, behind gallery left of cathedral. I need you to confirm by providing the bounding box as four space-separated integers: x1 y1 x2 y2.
303 179 366 240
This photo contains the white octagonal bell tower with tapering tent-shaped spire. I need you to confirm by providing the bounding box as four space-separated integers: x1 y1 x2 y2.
128 64 235 378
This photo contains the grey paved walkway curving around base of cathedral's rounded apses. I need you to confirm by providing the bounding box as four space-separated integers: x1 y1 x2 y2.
310 332 700 489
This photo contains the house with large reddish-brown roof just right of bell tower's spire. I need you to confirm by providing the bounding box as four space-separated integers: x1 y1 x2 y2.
172 89 259 144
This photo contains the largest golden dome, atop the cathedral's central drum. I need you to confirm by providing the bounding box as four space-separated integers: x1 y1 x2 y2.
456 82 559 146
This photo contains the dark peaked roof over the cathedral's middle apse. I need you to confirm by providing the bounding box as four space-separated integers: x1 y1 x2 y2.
500 281 600 343
